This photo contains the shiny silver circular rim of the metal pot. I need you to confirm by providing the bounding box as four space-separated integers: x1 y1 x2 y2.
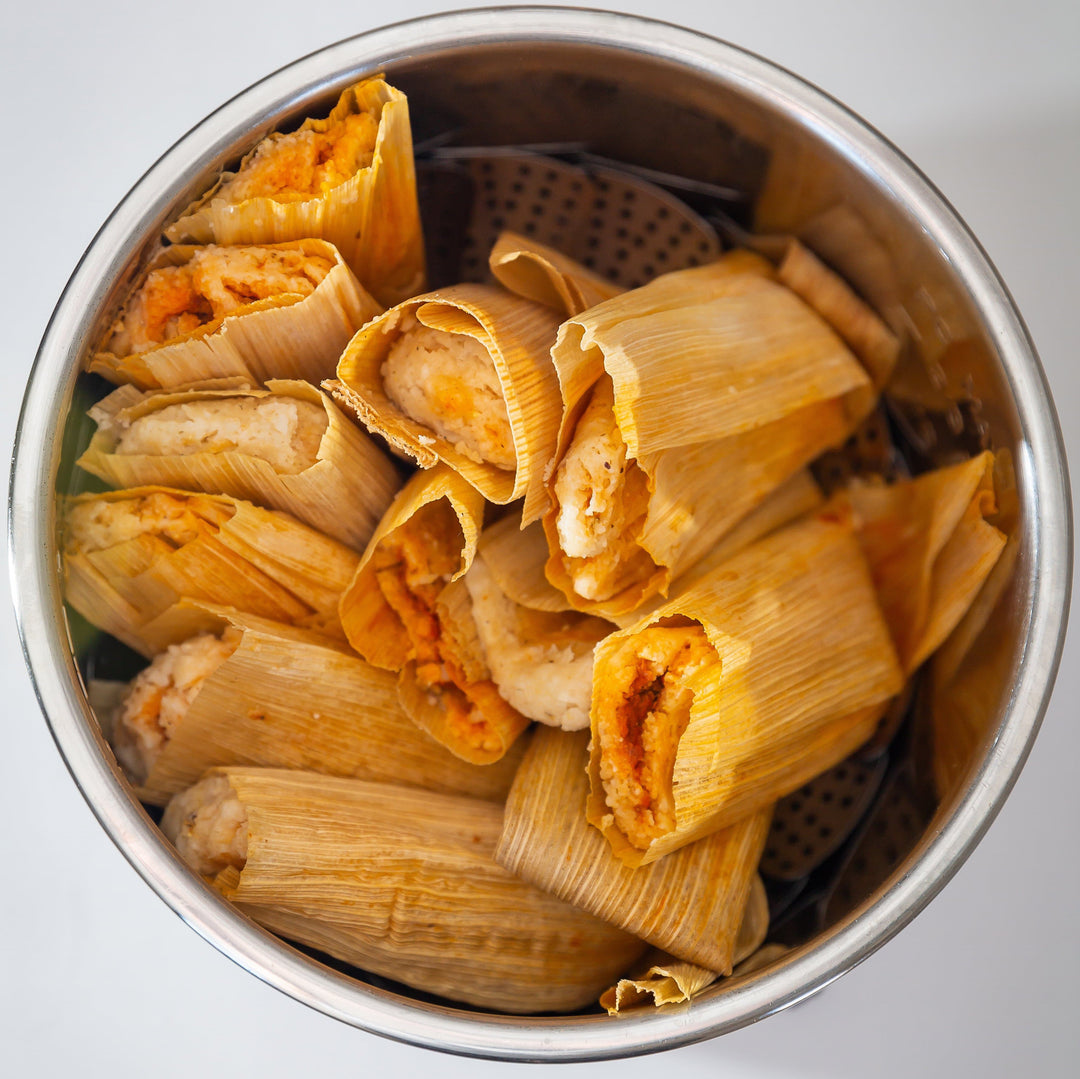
9 6 1072 1062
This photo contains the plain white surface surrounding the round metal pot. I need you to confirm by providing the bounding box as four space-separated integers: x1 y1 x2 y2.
0 0 1080 1079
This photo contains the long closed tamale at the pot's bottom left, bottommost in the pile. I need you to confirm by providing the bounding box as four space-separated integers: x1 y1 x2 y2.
163 768 645 1013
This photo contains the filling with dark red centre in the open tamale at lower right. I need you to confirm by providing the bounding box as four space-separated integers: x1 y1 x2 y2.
596 624 717 849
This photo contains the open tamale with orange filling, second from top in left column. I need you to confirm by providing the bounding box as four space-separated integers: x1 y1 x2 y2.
87 240 382 390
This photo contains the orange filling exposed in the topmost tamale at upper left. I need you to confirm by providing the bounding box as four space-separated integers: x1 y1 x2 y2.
214 112 379 203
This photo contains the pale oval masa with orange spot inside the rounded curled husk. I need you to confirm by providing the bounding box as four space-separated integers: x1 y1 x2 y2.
381 319 517 470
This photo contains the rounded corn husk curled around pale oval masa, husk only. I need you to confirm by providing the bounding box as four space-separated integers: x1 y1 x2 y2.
330 284 563 524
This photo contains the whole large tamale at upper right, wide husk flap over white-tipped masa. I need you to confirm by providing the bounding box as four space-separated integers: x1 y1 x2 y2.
543 252 875 620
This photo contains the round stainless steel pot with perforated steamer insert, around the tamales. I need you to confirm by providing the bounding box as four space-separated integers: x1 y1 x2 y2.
10 8 1071 1062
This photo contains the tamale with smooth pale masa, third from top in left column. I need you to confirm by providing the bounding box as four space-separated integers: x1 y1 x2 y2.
77 380 401 551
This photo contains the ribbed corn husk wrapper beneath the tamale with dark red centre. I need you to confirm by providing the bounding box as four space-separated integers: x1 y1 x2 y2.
495 727 772 976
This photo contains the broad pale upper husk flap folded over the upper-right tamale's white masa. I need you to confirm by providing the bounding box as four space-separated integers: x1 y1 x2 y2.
553 252 868 458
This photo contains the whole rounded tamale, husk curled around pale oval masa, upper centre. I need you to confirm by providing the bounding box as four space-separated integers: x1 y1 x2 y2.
329 284 563 524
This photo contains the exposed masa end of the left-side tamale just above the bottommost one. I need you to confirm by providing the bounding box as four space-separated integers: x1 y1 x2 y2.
112 633 238 783
